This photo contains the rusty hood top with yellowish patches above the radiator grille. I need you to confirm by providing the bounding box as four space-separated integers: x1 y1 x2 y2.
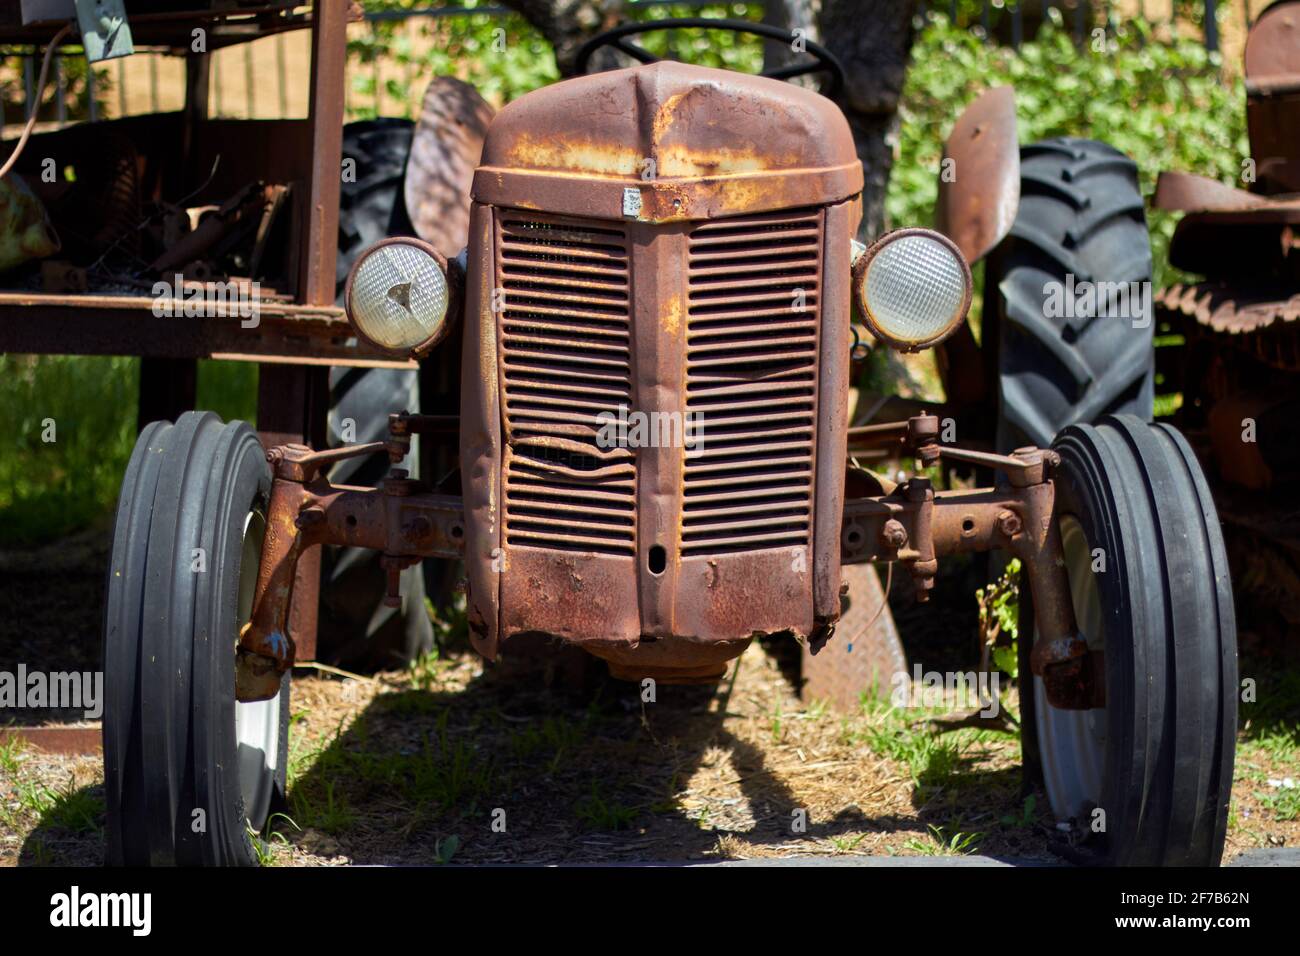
475 61 862 221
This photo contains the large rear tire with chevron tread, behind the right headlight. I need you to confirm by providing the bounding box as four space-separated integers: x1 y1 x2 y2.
984 137 1154 453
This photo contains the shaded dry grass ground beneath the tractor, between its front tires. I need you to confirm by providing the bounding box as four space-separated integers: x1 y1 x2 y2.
273 648 1045 864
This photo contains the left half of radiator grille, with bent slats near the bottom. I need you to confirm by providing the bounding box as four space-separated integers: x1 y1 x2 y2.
497 209 636 555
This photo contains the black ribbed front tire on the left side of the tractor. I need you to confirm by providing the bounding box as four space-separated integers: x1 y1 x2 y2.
104 412 289 866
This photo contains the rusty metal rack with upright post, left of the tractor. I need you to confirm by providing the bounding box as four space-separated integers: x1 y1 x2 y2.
0 0 361 657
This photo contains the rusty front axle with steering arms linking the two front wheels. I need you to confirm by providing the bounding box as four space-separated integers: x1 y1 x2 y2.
237 415 1104 709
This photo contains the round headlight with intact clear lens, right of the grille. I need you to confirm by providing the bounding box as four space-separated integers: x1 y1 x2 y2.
853 229 971 351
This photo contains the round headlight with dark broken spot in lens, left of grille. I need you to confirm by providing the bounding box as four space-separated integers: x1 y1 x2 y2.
343 238 450 355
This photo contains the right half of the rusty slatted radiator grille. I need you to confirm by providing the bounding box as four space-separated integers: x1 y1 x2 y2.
681 209 822 555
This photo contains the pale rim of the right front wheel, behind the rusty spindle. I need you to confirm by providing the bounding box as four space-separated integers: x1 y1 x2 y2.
1034 515 1106 819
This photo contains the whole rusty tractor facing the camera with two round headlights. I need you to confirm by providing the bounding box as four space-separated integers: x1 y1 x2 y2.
105 16 1236 864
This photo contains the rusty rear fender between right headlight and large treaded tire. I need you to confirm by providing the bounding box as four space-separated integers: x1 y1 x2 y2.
935 86 1021 264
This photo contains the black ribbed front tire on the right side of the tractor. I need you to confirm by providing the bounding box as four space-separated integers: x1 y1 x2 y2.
1021 416 1238 866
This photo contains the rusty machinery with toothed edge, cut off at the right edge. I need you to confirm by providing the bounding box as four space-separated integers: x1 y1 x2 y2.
1156 0 1300 646
